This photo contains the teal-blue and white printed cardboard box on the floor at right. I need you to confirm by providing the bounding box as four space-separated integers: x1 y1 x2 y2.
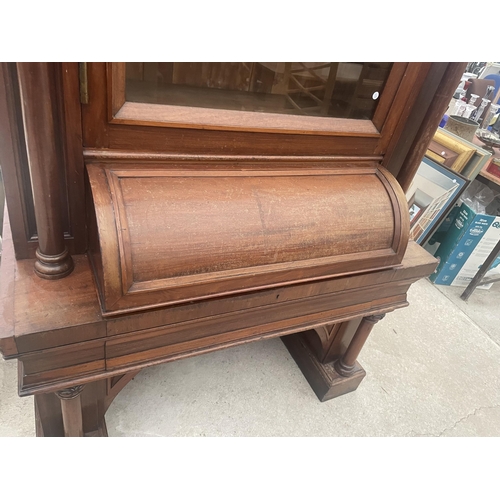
430 203 500 289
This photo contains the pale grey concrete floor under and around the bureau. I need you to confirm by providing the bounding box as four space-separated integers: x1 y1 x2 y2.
0 279 500 436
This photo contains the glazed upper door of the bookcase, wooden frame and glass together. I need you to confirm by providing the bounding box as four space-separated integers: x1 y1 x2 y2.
82 63 431 160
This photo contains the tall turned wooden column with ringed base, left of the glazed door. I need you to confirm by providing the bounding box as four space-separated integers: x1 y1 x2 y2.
17 63 73 279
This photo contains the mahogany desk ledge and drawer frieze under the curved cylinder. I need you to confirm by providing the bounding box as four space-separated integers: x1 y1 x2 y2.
0 235 436 394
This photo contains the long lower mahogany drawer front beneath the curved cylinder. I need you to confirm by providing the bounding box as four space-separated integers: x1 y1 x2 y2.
106 282 410 370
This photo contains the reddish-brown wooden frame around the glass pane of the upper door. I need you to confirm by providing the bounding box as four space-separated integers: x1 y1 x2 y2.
82 62 432 161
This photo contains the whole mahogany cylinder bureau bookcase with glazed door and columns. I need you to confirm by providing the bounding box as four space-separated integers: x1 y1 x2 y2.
0 63 465 436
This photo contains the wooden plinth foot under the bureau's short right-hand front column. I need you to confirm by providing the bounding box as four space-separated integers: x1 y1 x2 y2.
281 333 366 402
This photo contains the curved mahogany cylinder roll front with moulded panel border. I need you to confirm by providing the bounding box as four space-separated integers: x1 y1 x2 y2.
87 163 409 315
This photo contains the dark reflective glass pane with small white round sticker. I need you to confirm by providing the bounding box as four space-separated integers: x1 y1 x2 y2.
126 62 392 120
